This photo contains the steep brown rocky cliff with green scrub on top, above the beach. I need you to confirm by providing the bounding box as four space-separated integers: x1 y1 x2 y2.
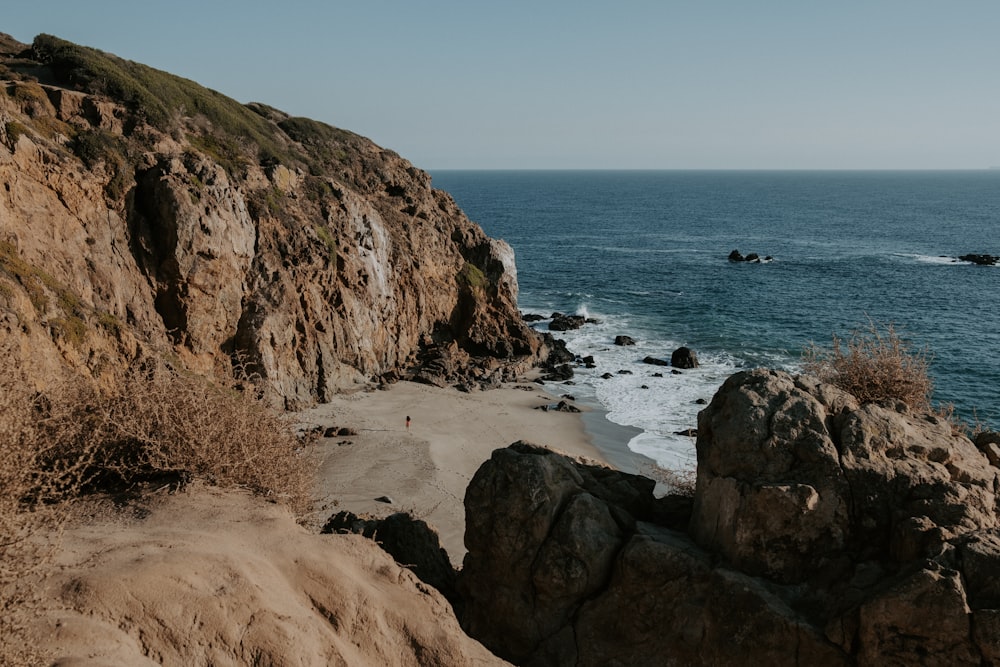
0 36 540 407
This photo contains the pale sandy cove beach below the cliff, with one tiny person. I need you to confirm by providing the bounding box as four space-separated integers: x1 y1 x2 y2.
297 382 648 565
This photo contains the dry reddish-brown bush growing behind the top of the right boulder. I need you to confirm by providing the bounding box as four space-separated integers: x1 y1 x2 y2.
803 322 933 410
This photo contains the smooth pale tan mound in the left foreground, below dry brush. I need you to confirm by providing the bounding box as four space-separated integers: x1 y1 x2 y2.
37 487 506 667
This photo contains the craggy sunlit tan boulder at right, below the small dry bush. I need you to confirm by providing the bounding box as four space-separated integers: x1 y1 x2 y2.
691 370 997 582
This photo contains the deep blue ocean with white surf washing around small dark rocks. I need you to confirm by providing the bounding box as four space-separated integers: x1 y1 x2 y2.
432 171 1000 467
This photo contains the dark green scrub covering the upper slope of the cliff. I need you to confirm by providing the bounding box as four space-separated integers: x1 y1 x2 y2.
7 34 378 185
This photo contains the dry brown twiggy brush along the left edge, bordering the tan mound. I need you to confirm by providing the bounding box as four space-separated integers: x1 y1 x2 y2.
0 355 312 665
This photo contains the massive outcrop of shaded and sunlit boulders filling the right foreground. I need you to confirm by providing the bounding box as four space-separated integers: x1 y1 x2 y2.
459 370 1000 665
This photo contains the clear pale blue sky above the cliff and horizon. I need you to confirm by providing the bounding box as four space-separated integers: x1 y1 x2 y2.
0 0 1000 169
